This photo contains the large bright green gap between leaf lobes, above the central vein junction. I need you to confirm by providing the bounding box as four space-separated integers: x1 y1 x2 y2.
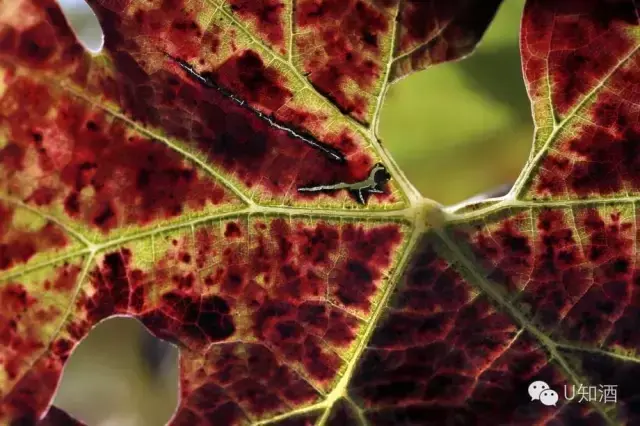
379 0 533 205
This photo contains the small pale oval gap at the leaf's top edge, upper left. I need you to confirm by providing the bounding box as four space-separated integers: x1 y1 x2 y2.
58 0 104 53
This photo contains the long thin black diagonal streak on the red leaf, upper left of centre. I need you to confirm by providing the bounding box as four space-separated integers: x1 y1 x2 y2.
165 53 346 163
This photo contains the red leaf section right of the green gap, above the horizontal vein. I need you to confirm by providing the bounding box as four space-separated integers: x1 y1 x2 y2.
516 0 640 199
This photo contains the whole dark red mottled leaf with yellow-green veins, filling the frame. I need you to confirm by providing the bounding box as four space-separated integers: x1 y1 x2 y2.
0 0 640 425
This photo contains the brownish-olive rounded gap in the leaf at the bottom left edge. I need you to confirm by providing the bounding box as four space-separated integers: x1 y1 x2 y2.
54 317 178 426
